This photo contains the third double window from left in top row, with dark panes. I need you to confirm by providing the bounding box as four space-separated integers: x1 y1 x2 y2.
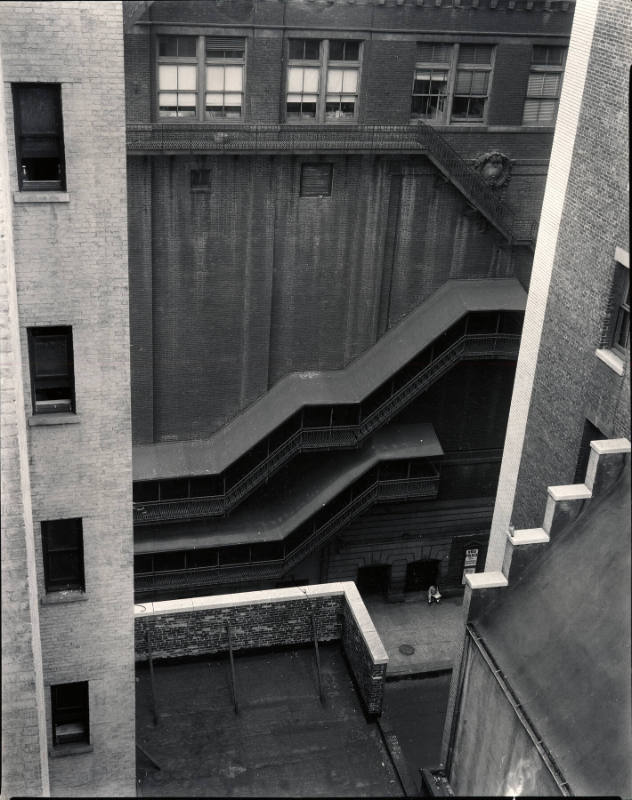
411 42 494 124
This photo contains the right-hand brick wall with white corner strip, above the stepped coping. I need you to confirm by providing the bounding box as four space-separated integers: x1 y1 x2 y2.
486 0 632 571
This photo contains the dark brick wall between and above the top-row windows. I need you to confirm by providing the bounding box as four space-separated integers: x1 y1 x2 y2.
126 0 572 128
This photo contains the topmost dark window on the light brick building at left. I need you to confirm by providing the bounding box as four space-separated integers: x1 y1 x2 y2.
12 83 66 191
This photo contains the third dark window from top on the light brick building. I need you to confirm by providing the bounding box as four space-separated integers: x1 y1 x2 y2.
42 518 85 592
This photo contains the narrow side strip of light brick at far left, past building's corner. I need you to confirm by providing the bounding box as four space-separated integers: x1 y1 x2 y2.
0 49 49 796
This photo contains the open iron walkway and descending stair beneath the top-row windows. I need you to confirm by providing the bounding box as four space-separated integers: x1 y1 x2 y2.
127 121 536 248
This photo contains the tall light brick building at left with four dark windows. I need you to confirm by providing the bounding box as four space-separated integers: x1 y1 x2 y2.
0 2 135 796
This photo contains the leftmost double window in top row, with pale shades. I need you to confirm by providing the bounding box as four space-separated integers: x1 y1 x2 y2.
157 35 245 121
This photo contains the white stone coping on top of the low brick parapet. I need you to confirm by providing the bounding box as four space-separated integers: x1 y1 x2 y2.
134 581 388 665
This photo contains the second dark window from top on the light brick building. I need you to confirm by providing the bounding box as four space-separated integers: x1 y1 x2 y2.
28 327 75 414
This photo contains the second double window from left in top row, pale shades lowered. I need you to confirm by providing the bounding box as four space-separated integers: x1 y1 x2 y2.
286 39 360 122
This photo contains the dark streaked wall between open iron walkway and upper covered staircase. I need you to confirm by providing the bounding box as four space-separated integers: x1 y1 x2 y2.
129 155 511 443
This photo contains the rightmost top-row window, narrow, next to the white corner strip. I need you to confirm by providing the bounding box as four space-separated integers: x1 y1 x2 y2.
522 45 566 126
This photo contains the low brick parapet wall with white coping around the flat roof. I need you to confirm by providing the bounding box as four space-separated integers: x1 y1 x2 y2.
134 581 388 715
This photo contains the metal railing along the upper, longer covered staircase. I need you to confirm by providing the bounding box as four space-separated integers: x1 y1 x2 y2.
134 333 520 524
